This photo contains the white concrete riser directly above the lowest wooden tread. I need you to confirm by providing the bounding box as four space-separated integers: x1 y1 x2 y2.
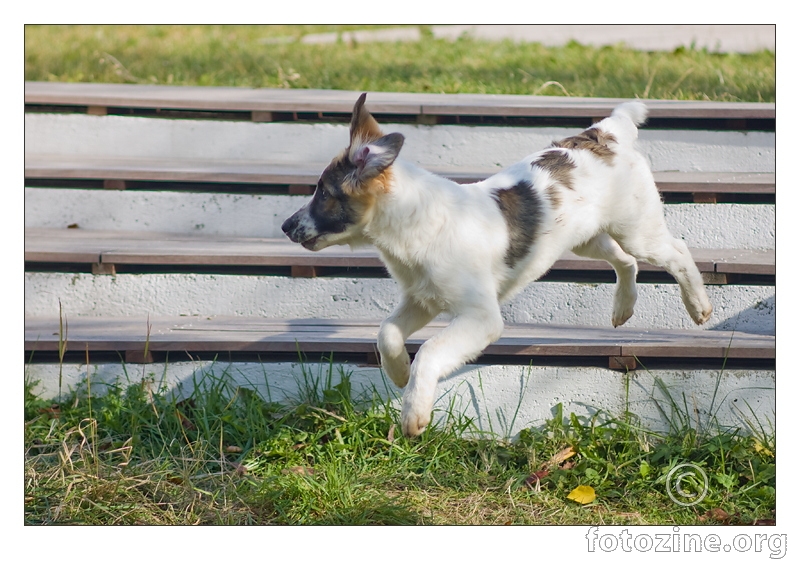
25 272 775 333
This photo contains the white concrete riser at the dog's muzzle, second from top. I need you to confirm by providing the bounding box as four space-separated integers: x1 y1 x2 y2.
25 188 775 249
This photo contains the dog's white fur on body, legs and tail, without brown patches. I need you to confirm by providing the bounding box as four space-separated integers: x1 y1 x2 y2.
284 102 711 436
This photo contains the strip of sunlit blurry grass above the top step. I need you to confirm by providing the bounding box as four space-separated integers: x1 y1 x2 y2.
25 26 775 102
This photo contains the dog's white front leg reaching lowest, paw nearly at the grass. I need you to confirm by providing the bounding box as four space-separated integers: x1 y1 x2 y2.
402 305 503 437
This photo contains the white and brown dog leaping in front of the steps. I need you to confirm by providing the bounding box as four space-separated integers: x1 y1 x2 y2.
282 94 711 436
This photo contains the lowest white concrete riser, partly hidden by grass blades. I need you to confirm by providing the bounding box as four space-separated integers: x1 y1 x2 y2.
26 362 775 437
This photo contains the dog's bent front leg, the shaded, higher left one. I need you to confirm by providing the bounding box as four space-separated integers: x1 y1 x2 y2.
378 299 436 387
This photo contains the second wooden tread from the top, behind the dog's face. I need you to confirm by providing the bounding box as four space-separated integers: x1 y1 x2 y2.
25 154 775 202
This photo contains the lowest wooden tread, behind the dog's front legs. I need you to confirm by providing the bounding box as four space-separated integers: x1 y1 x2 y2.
25 316 775 367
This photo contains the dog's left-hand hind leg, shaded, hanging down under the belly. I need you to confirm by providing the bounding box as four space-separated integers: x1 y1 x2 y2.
572 233 638 328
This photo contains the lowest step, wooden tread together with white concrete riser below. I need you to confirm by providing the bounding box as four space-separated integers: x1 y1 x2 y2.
25 316 775 438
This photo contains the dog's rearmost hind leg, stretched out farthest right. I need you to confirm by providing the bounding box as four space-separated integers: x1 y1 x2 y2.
616 228 712 325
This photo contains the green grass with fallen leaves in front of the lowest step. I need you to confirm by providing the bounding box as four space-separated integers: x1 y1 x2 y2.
25 368 775 525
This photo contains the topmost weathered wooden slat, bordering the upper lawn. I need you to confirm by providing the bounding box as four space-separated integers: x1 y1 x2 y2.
25 82 775 119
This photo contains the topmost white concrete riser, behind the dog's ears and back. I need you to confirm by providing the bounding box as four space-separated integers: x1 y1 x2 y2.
25 113 775 173
